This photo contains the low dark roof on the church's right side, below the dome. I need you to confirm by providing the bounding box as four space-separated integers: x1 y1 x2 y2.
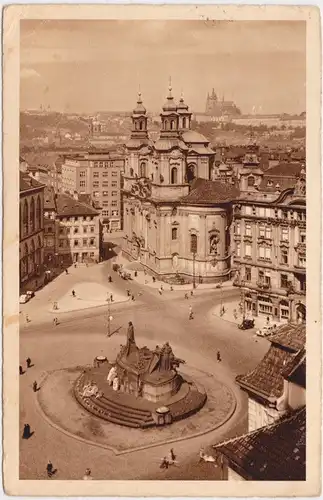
182 178 240 205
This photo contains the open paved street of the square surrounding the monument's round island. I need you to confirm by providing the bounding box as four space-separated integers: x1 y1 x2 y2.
20 262 268 479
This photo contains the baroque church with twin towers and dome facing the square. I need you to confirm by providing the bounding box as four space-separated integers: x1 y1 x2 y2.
122 87 239 283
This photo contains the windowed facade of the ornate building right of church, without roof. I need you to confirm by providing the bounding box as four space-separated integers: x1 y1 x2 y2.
232 197 306 322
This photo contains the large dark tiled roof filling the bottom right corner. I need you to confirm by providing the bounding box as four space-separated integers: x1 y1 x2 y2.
213 407 306 481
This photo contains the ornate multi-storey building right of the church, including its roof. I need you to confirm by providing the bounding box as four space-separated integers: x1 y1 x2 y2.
231 164 306 323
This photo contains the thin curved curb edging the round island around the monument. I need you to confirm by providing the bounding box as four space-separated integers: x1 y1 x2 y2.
36 368 237 456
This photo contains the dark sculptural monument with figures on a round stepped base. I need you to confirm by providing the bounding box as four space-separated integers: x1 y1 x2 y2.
74 322 206 428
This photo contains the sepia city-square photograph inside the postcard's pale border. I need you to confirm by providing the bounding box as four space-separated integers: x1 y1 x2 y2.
1 6 320 495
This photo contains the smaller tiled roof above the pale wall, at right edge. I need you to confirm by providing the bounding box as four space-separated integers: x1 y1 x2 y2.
236 325 305 402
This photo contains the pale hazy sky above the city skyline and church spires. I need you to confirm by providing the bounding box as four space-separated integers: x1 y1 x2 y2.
20 20 306 113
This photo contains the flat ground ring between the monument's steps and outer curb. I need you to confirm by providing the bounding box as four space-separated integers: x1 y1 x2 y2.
36 366 237 455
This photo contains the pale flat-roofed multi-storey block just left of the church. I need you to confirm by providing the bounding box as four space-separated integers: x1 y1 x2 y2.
62 152 125 231
